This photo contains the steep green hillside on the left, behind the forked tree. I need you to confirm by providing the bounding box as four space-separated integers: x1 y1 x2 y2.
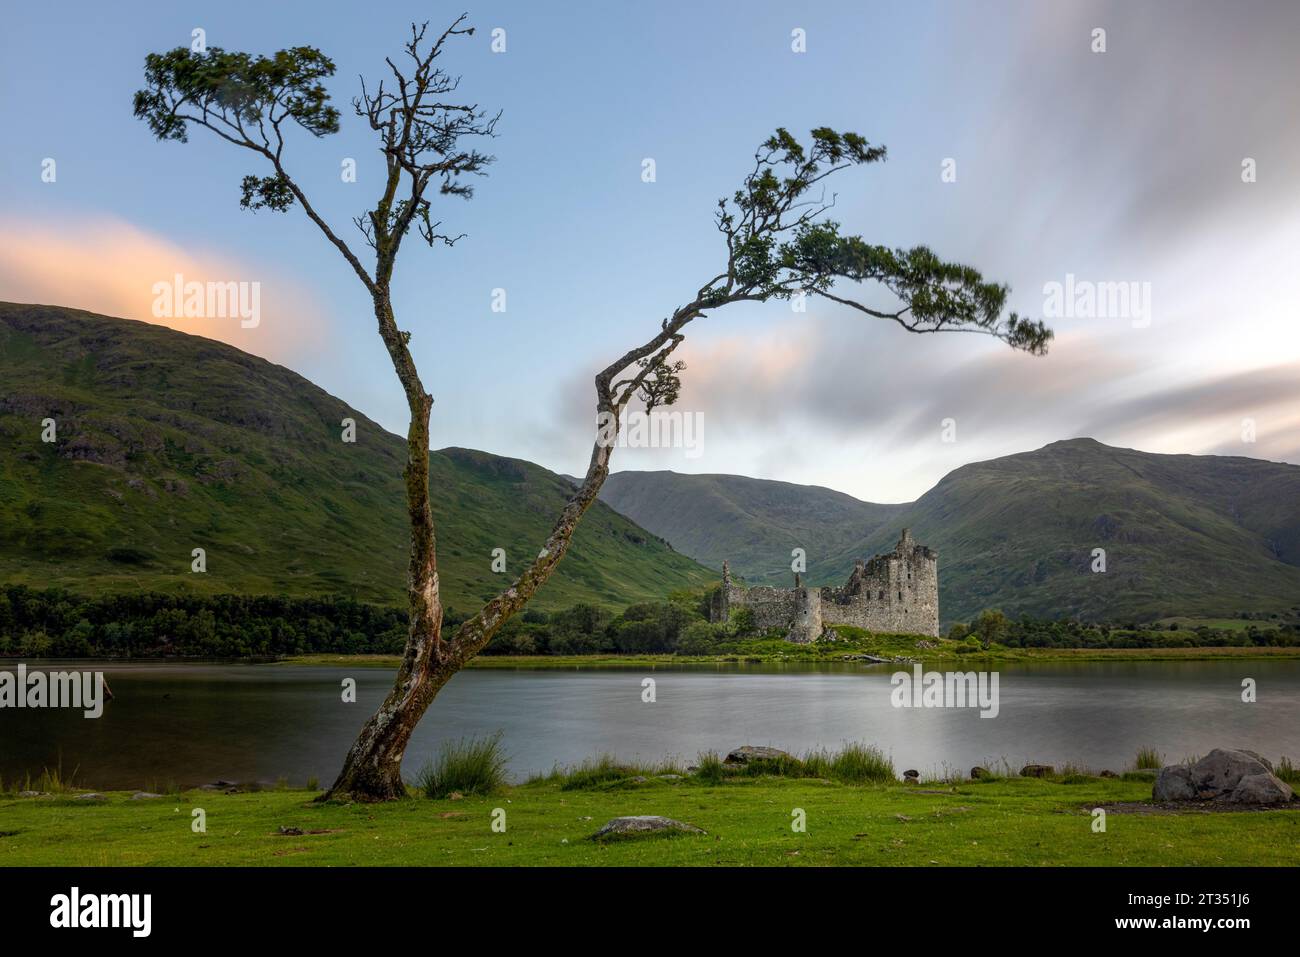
0 303 716 609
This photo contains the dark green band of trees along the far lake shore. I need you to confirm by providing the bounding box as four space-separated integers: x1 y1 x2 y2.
0 585 1300 658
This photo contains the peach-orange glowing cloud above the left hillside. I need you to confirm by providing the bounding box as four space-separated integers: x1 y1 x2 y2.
0 218 328 364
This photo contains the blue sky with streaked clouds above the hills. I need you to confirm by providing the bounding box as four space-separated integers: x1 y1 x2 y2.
0 0 1300 502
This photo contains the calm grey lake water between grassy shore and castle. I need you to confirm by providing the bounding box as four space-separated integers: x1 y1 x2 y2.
0 661 1300 789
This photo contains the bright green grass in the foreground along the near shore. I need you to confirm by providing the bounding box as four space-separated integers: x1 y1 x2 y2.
0 778 1300 866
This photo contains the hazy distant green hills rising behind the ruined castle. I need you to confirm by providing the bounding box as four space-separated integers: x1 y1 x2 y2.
607 438 1300 623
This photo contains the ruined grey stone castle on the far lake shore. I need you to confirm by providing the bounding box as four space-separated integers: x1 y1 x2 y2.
709 528 939 642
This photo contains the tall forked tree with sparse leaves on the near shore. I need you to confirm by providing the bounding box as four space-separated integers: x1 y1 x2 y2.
135 16 1052 800
